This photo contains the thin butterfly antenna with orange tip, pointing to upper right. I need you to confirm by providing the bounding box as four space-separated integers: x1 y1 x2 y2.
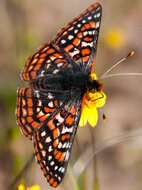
100 51 135 79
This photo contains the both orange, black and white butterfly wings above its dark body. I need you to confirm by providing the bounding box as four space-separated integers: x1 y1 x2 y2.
21 3 102 81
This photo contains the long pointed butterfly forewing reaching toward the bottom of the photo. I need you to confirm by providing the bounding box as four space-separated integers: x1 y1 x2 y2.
34 102 81 187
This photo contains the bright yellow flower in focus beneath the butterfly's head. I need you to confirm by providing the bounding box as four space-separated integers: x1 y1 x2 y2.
79 74 106 127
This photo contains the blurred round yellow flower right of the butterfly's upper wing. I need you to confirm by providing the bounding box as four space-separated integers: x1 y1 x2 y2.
105 28 126 49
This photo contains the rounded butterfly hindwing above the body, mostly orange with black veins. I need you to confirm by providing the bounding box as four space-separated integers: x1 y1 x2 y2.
21 42 69 81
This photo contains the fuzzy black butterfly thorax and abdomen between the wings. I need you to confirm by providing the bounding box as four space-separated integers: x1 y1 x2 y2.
31 72 89 91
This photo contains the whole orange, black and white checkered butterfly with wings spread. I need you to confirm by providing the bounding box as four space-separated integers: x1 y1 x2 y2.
16 3 102 187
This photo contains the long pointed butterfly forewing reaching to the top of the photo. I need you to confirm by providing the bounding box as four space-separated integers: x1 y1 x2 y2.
54 3 102 72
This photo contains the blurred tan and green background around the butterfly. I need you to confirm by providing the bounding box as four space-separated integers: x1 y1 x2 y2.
0 0 142 190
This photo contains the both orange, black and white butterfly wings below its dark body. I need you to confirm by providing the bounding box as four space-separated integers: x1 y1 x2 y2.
17 88 81 187
